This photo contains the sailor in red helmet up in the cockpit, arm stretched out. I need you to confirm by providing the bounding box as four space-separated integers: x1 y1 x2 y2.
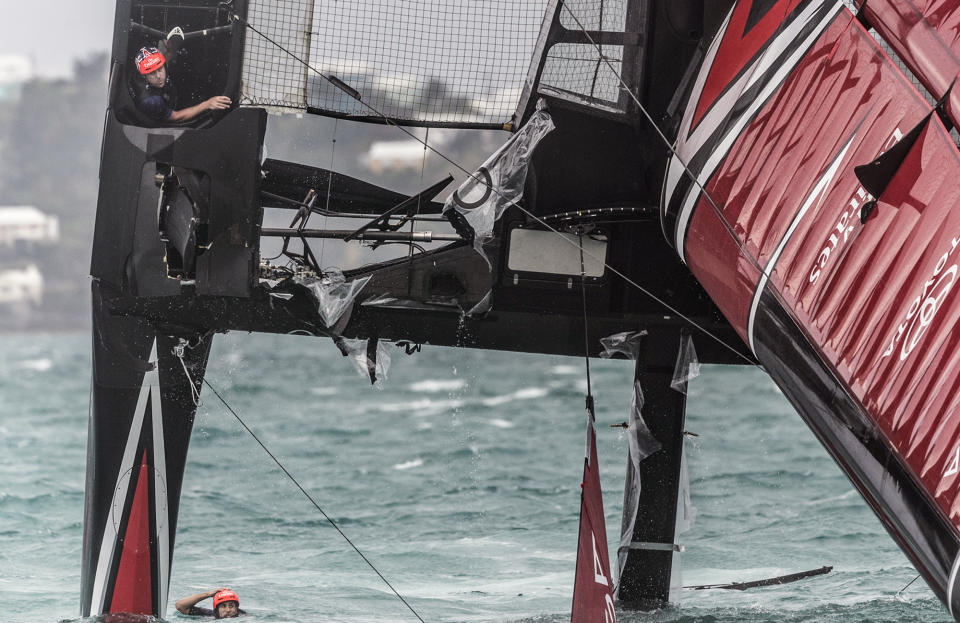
129 28 231 124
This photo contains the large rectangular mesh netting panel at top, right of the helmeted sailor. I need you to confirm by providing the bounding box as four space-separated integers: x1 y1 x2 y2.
243 0 550 127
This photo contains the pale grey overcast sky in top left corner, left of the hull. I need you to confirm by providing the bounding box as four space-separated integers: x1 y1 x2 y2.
0 0 116 77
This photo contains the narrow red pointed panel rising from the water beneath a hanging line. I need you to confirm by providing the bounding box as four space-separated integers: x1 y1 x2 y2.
570 414 617 623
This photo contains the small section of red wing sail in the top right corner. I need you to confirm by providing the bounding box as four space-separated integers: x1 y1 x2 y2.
863 0 960 124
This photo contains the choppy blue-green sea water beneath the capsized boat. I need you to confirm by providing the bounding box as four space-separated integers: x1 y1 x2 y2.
0 333 950 623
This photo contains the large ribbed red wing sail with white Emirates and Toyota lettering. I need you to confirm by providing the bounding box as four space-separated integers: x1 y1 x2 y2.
662 0 960 617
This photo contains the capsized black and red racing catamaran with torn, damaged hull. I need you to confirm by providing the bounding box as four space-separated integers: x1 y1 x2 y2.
81 0 960 616
